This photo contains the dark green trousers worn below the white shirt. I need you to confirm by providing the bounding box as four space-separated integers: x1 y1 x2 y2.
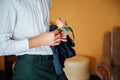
13 55 67 80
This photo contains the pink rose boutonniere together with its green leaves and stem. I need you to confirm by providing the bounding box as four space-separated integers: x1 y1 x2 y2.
56 18 74 39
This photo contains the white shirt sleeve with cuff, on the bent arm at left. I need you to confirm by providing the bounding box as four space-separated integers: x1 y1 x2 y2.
0 0 29 56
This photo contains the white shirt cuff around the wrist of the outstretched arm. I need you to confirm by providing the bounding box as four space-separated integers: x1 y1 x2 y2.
15 39 29 52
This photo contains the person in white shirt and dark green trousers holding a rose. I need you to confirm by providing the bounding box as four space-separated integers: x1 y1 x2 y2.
0 0 67 80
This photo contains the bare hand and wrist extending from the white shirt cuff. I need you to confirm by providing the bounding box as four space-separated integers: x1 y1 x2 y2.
29 30 61 48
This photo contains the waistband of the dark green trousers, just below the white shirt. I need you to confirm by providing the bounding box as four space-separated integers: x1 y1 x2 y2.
17 54 53 62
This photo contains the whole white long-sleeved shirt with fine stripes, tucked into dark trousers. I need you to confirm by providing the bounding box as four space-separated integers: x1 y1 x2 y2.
0 0 53 55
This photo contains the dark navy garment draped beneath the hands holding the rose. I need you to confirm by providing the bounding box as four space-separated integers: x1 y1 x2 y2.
50 25 76 75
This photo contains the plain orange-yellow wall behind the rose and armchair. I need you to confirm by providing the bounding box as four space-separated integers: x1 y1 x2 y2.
50 0 120 74
